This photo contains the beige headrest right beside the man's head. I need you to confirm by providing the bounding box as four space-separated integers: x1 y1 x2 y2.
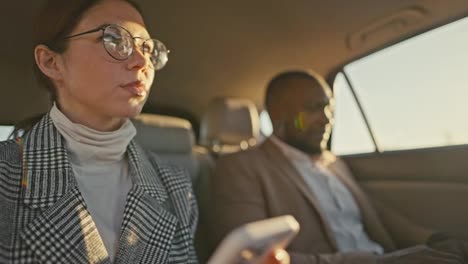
200 97 260 152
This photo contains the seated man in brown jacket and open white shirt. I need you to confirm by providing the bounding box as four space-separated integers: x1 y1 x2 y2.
212 71 468 264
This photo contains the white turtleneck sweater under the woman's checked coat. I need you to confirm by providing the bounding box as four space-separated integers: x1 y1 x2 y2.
50 104 136 260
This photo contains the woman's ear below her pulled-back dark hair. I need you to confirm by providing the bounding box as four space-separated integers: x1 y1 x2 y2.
34 44 62 81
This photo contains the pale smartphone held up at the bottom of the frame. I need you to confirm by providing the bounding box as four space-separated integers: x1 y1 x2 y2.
208 215 299 264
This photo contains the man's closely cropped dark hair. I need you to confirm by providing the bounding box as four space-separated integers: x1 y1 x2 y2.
265 70 331 110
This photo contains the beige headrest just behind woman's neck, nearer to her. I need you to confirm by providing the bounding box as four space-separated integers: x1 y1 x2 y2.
133 114 195 154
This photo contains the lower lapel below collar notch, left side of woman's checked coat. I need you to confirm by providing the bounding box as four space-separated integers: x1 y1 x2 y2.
21 188 110 264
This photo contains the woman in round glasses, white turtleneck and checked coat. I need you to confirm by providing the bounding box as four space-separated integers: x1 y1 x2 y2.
0 0 284 264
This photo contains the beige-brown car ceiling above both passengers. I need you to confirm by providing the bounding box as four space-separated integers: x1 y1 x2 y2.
0 0 468 124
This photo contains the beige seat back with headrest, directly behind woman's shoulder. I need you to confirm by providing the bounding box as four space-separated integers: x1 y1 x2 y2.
133 114 214 263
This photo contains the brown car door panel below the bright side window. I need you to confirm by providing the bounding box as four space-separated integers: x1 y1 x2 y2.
343 148 468 240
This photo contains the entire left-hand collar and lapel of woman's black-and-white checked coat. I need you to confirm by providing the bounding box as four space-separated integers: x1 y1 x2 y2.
19 114 110 264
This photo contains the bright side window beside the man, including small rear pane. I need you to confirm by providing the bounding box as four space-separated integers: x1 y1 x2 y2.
332 18 468 154
